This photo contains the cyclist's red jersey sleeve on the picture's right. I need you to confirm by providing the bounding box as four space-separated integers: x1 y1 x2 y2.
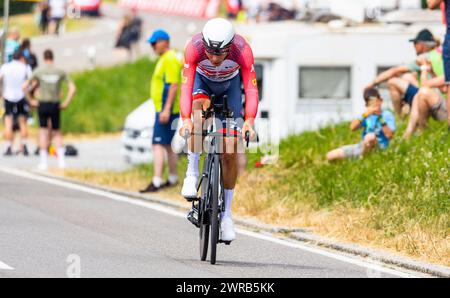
239 44 259 122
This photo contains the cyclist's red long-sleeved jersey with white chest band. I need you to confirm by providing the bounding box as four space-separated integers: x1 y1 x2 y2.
181 33 259 120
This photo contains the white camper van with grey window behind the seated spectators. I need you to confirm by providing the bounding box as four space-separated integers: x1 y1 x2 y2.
239 18 445 143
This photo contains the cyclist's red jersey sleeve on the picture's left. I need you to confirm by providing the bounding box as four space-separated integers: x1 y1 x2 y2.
180 42 198 120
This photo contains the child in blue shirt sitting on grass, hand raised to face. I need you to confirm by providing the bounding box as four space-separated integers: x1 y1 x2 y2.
327 88 396 162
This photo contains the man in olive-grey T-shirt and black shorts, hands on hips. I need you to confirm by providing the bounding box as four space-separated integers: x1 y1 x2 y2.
24 50 76 170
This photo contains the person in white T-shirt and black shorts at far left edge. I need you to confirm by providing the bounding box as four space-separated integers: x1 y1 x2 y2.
0 51 32 156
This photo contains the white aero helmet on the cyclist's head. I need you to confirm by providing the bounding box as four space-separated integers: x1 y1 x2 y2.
202 18 235 54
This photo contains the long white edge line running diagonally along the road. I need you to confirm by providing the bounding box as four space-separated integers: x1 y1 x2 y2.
0 166 419 278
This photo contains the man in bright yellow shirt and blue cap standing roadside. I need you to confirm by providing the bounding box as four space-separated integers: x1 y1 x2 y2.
141 30 181 193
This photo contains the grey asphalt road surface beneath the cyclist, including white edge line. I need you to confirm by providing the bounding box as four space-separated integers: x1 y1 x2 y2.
0 167 420 278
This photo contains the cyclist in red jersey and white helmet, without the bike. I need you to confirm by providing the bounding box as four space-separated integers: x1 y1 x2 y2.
180 18 258 241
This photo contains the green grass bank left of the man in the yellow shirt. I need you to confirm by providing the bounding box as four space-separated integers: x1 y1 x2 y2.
62 59 154 133
